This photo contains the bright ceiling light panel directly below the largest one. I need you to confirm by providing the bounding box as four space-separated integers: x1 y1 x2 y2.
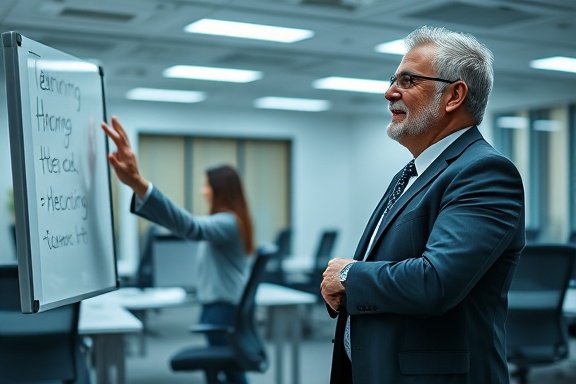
163 65 262 83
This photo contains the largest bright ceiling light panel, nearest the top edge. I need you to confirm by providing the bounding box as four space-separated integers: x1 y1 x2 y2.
184 19 314 43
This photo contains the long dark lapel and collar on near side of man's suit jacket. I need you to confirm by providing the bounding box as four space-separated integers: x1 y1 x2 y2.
364 126 482 260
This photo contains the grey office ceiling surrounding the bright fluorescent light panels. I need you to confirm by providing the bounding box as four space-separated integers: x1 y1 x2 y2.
0 0 576 114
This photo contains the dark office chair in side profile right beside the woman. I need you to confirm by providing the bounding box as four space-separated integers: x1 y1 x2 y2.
170 245 277 384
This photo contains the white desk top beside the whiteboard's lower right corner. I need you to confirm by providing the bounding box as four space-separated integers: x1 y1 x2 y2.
78 298 142 335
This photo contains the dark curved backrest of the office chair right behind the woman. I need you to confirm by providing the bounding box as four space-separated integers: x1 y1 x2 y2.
232 245 277 372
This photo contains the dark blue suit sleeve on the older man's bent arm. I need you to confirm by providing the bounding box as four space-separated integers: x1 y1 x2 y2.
346 154 524 316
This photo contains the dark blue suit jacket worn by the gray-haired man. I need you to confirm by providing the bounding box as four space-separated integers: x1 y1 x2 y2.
330 127 525 384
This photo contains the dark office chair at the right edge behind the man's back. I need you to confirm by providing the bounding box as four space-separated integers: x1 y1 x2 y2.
506 244 576 384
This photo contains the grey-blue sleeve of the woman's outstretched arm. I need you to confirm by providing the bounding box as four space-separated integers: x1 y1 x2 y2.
130 187 239 243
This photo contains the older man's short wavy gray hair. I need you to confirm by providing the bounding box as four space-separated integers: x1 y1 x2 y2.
404 26 494 124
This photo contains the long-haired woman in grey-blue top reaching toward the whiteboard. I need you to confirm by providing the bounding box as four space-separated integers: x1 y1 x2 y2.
102 116 254 384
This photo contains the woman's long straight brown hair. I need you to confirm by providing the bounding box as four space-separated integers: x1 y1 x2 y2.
206 165 254 255
